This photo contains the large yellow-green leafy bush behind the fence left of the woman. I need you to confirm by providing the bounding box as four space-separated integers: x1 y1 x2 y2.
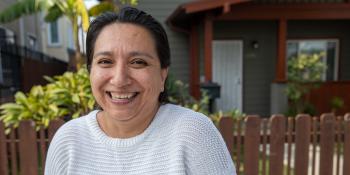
0 68 95 132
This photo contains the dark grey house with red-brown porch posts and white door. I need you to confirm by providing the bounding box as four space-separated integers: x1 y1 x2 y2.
138 0 350 116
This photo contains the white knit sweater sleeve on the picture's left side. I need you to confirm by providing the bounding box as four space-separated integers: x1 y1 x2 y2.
45 126 69 175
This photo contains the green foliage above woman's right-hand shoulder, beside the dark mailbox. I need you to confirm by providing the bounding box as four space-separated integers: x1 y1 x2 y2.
166 74 209 114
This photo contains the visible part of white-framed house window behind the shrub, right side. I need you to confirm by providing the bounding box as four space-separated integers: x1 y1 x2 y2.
287 39 339 81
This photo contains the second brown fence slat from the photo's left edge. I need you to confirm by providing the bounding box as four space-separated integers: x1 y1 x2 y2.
18 121 38 175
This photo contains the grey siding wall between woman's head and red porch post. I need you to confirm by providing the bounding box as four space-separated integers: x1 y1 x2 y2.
137 0 190 83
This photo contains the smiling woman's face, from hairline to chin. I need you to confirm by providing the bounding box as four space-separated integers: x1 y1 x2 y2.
90 23 168 121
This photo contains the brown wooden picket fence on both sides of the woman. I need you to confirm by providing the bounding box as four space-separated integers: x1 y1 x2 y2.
0 114 350 175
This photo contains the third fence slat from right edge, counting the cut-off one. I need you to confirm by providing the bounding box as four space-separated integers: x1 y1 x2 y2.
294 114 311 175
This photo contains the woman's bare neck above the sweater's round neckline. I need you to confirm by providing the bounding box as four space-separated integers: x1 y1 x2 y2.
97 105 159 138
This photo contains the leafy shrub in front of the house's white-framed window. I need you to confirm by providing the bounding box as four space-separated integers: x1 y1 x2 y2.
286 53 327 116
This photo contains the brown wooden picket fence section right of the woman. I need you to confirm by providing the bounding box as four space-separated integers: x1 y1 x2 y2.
219 114 350 175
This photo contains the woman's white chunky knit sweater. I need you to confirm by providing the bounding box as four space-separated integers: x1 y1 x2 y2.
45 104 236 175
